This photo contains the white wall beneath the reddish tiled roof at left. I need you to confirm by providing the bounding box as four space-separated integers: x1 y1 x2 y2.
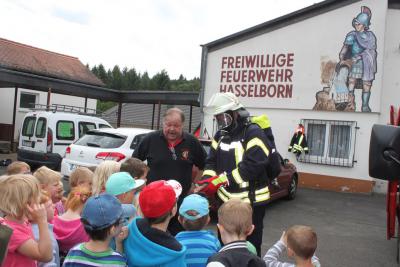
0 88 97 141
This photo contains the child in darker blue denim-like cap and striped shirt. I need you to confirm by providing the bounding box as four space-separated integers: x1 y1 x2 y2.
63 194 127 267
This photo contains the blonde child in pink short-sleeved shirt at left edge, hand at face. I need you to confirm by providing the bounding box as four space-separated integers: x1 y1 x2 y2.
0 174 53 267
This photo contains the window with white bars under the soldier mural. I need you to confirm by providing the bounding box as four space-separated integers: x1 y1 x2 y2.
298 119 357 167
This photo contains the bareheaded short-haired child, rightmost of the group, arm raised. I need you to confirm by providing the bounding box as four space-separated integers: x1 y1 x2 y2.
264 225 321 267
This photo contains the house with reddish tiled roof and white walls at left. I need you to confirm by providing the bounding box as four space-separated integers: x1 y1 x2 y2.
0 38 104 144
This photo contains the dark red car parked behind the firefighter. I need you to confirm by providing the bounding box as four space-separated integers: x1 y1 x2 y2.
193 140 299 213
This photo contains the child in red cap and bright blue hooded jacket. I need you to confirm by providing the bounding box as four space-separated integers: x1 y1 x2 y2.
124 180 186 267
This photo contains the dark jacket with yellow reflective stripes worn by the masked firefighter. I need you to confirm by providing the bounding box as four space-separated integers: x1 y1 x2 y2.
203 124 270 205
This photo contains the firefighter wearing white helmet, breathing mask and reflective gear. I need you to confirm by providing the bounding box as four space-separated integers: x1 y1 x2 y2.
198 93 270 255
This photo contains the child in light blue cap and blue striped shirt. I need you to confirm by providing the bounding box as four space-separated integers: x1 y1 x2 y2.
176 194 221 267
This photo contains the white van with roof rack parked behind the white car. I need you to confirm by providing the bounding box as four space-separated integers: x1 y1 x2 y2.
17 111 112 170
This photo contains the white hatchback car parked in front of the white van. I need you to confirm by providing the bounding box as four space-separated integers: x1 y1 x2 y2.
61 128 153 177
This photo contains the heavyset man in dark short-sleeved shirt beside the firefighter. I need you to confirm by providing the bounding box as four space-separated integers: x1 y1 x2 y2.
132 108 207 235
